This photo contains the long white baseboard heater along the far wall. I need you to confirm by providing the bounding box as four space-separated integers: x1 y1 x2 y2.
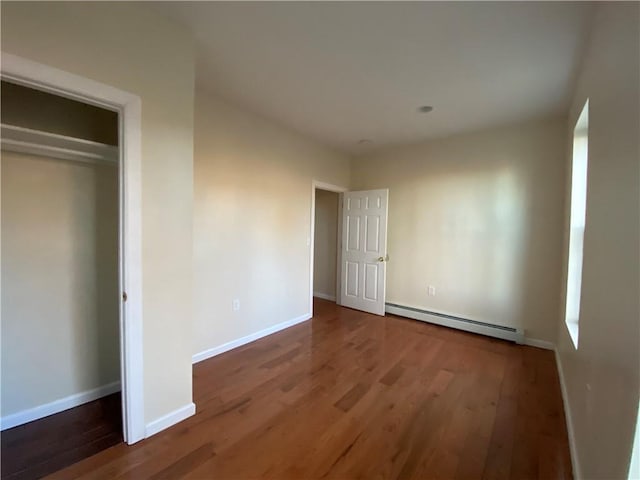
385 303 524 344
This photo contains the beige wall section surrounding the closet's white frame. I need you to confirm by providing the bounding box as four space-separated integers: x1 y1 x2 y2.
2 2 194 423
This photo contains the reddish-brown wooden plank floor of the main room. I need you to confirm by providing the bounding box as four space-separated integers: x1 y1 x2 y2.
40 300 571 479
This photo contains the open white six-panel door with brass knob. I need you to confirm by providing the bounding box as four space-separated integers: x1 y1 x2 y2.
340 189 389 315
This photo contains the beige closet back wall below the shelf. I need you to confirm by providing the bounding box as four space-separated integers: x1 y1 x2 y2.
1 151 120 416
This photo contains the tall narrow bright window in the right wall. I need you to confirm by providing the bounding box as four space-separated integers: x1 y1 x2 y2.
565 100 589 348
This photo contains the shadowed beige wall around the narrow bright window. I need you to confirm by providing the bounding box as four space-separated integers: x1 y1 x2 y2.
558 3 640 478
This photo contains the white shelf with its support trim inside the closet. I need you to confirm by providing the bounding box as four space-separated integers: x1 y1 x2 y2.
0 123 118 166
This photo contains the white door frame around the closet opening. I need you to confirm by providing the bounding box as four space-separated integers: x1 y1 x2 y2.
0 52 145 444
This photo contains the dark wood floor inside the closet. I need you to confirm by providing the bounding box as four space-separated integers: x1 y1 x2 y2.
0 393 122 480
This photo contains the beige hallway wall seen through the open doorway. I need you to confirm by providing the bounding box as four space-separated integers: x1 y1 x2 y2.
313 190 340 298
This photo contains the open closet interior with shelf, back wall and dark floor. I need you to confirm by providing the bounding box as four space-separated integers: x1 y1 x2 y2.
0 80 123 478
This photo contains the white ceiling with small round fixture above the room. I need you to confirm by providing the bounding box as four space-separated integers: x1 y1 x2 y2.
154 2 593 154
